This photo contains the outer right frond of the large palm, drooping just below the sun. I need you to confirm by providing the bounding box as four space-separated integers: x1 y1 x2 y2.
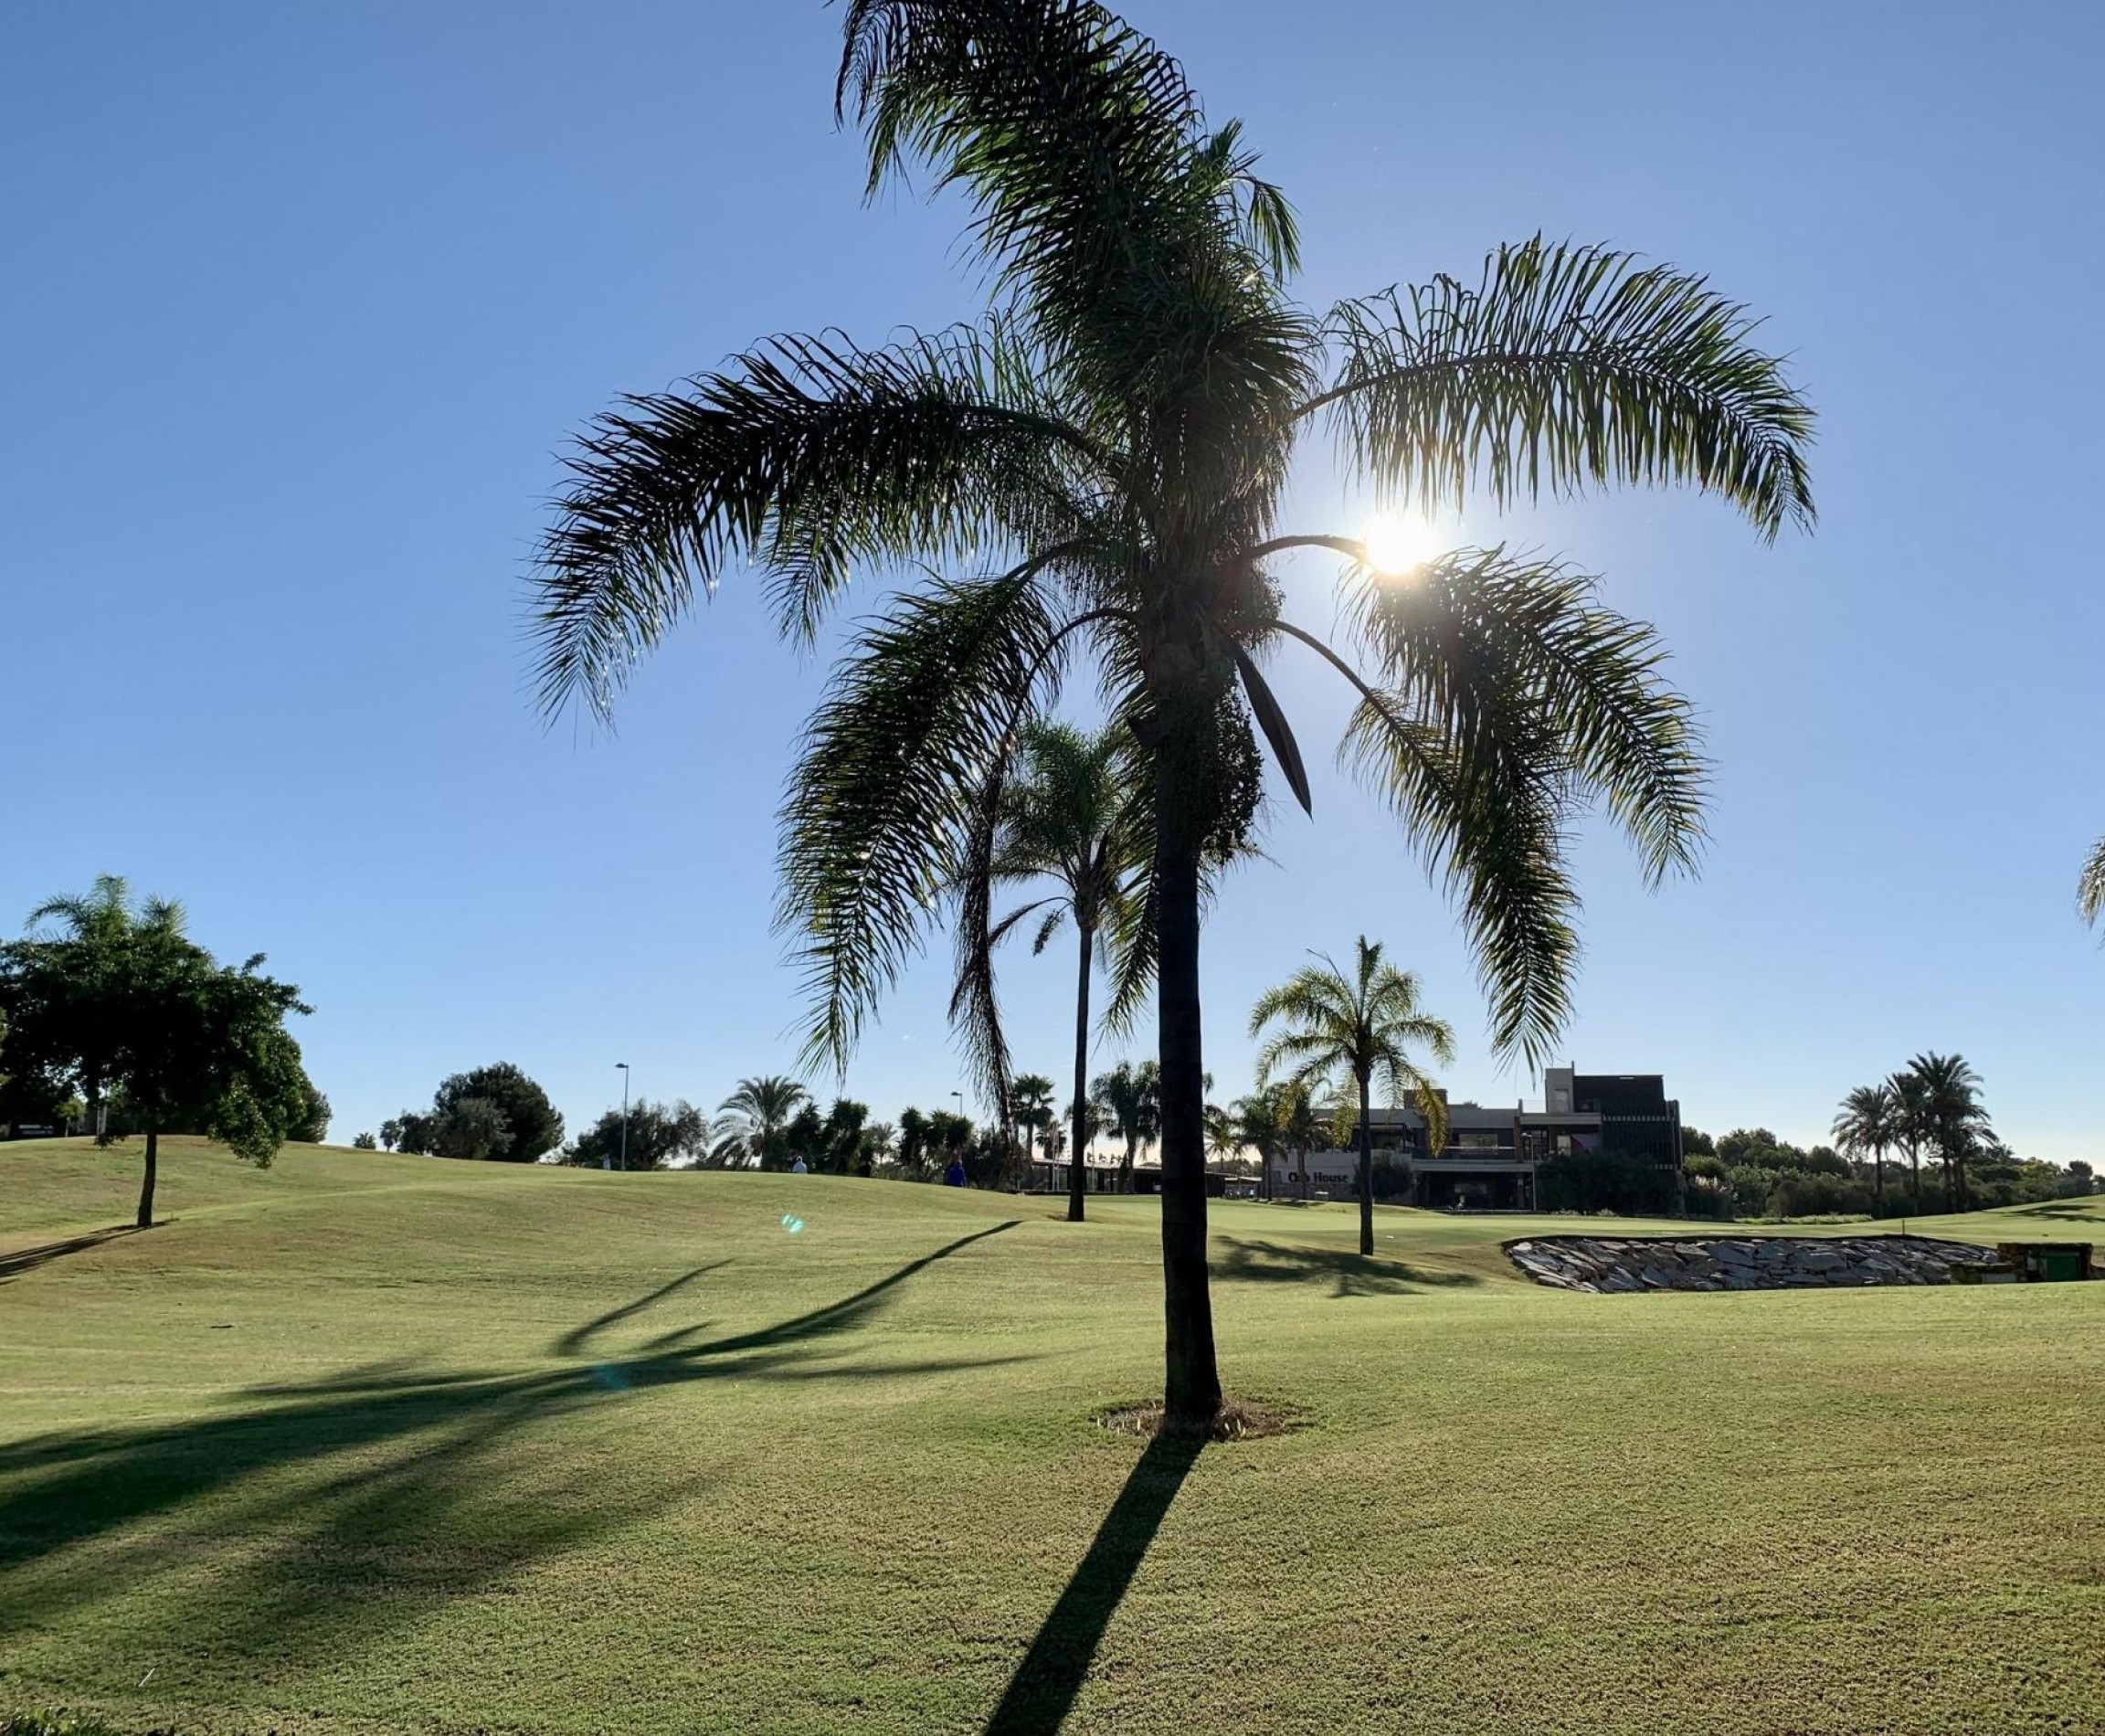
1345 547 1708 884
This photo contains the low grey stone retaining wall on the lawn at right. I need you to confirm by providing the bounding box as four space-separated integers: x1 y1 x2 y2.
1505 1235 1995 1294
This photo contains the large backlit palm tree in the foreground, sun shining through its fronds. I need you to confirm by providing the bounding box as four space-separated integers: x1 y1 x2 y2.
537 0 1813 1423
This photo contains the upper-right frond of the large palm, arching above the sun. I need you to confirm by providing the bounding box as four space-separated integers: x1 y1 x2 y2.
1305 236 1813 536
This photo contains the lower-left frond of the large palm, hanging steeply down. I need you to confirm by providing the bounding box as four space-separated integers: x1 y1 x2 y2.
777 566 1059 1067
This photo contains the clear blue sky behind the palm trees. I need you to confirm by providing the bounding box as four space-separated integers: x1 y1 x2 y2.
0 0 2105 1161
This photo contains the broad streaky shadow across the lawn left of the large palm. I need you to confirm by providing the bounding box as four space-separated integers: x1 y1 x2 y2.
0 1221 1015 1662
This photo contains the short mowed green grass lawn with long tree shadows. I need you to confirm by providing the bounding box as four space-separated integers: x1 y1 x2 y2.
0 1143 2105 1736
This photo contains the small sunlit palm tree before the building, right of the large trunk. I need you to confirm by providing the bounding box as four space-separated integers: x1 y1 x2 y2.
1251 935 1454 1254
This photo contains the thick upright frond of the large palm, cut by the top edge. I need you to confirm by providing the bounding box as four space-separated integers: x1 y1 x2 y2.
838 0 1314 473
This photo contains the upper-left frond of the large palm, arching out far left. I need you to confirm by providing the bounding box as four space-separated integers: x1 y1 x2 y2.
533 326 1090 715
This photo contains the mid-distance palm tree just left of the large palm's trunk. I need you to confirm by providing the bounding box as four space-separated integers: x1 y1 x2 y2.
968 720 1151 1223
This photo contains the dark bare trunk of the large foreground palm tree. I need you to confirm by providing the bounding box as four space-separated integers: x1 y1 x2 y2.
1156 753 1221 1424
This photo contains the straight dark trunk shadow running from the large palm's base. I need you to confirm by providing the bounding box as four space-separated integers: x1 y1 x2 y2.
985 1429 1206 1736
